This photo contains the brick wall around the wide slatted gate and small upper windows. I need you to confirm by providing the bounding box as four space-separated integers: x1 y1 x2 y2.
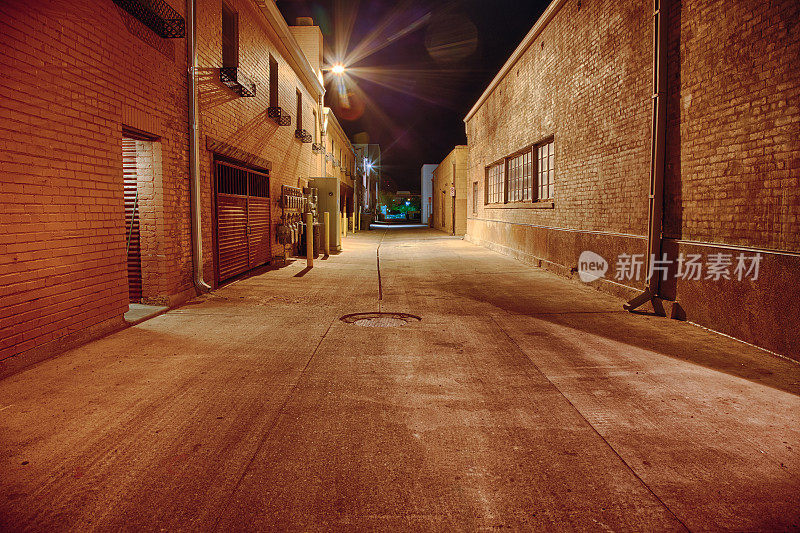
197 0 321 281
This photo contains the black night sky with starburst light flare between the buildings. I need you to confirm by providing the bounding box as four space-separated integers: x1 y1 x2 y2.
277 0 549 192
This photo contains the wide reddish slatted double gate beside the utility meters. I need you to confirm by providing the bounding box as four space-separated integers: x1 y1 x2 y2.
215 161 272 282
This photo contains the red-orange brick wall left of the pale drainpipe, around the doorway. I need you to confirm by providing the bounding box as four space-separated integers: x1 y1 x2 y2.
0 0 191 368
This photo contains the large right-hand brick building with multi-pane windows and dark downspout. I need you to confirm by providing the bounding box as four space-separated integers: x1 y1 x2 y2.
465 0 800 358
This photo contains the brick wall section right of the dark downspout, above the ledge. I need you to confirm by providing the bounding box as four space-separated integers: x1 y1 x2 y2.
665 0 800 251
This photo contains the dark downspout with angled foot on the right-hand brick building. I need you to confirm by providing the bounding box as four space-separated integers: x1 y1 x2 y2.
623 0 667 314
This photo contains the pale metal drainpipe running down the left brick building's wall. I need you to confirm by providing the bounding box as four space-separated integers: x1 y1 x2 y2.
186 0 211 293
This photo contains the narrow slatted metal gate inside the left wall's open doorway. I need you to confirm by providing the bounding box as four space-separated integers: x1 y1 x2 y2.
122 137 142 302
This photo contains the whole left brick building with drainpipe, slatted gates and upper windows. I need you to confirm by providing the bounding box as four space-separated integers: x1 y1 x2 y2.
0 0 334 374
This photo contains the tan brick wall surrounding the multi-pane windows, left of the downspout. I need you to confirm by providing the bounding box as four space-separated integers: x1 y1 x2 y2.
466 0 652 243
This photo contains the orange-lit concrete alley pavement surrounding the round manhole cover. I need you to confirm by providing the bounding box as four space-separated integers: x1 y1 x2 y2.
0 229 800 531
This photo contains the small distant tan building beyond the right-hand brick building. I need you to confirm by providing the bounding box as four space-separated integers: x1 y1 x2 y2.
432 145 469 235
